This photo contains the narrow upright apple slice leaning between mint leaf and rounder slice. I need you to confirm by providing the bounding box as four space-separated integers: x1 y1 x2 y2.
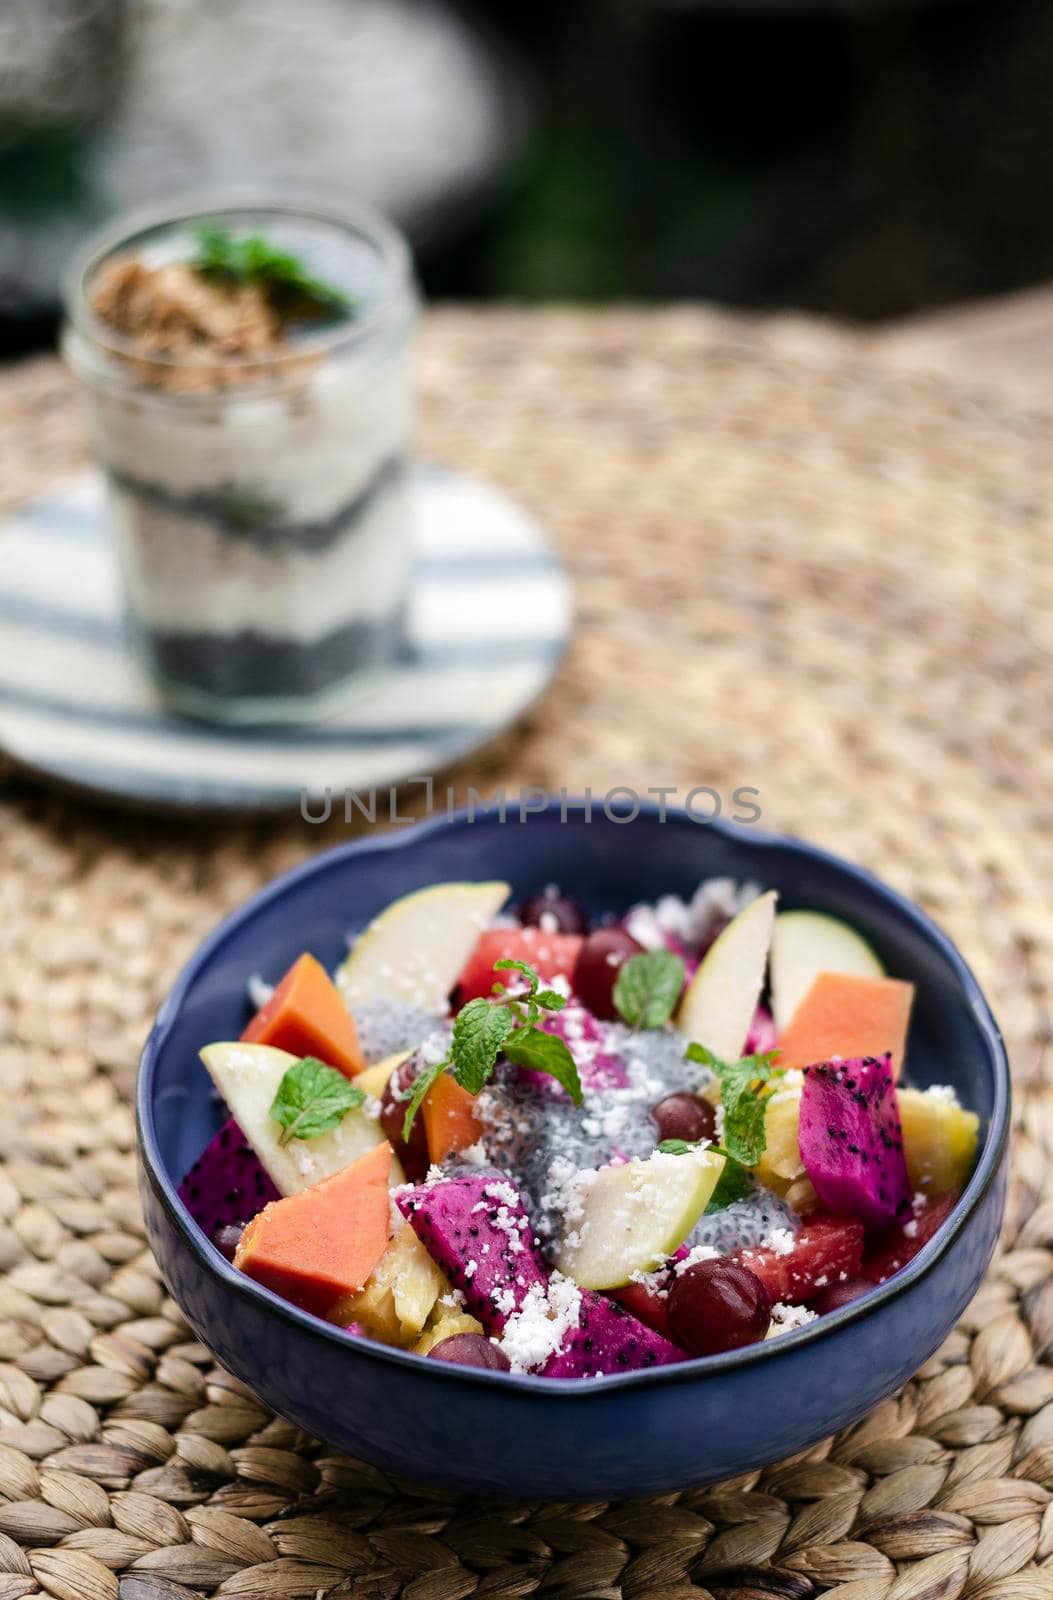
677 890 778 1061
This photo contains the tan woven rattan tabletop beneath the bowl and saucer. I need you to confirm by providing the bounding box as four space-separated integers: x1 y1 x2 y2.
0 312 1053 1600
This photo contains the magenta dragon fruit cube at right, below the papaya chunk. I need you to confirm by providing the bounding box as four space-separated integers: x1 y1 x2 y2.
799 1054 911 1229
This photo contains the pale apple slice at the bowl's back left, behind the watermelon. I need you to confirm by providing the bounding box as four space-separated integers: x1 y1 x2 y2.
336 883 509 1016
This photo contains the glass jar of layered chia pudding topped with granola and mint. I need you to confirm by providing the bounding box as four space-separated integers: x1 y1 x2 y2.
64 196 416 722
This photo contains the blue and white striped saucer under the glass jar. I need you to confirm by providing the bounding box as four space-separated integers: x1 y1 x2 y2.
0 466 573 811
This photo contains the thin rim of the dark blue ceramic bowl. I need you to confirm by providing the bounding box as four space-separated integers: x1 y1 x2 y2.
136 798 1011 1400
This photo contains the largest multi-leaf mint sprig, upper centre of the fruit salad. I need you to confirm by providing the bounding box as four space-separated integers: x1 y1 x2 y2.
402 957 581 1139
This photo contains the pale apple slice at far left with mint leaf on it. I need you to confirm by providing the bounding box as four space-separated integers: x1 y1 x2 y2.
202 1040 403 1195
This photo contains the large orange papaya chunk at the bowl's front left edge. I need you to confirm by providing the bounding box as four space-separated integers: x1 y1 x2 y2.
234 1142 392 1317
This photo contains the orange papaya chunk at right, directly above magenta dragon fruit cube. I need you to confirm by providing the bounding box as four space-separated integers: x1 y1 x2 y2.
778 973 914 1078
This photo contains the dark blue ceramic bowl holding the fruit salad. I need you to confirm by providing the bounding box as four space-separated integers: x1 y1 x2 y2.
138 808 1010 1499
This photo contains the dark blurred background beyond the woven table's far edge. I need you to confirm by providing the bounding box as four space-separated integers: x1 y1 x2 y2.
0 0 1053 355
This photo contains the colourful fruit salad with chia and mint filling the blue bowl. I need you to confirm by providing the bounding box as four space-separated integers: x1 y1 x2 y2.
179 878 979 1379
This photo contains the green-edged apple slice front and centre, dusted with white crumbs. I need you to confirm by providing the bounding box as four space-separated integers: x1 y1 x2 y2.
555 1149 723 1290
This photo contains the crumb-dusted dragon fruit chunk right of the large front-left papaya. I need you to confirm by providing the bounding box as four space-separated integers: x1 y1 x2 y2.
395 1173 549 1333
